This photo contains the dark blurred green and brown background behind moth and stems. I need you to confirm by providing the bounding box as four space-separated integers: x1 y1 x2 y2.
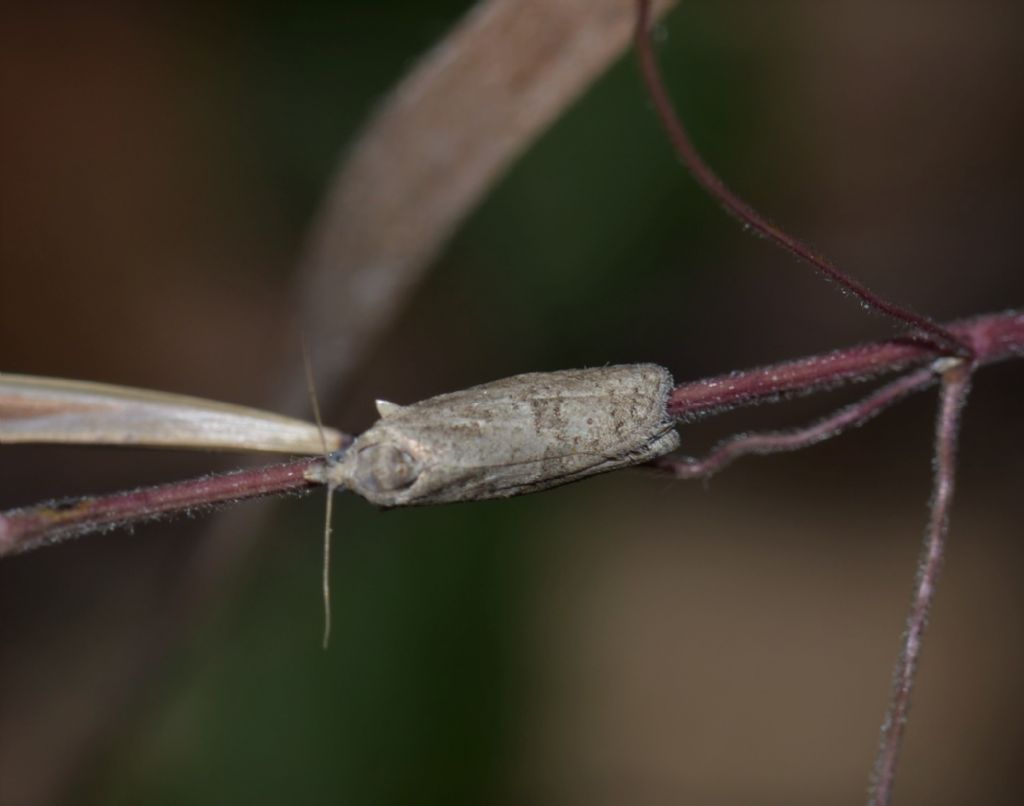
0 0 1024 806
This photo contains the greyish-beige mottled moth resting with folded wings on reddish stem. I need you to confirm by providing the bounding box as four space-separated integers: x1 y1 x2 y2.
307 364 679 507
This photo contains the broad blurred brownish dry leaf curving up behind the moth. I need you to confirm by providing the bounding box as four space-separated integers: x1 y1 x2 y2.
292 0 674 411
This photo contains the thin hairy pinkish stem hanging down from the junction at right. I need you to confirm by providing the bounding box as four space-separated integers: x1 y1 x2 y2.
867 364 972 806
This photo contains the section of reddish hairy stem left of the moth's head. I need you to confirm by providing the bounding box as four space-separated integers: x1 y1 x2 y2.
0 458 324 557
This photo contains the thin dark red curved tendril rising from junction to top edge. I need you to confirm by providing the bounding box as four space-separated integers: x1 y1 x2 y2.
635 0 972 357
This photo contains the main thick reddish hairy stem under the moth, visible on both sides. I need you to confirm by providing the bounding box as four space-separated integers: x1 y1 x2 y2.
0 310 1024 557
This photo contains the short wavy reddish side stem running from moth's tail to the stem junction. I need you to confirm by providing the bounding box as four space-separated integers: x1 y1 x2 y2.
651 368 936 478
